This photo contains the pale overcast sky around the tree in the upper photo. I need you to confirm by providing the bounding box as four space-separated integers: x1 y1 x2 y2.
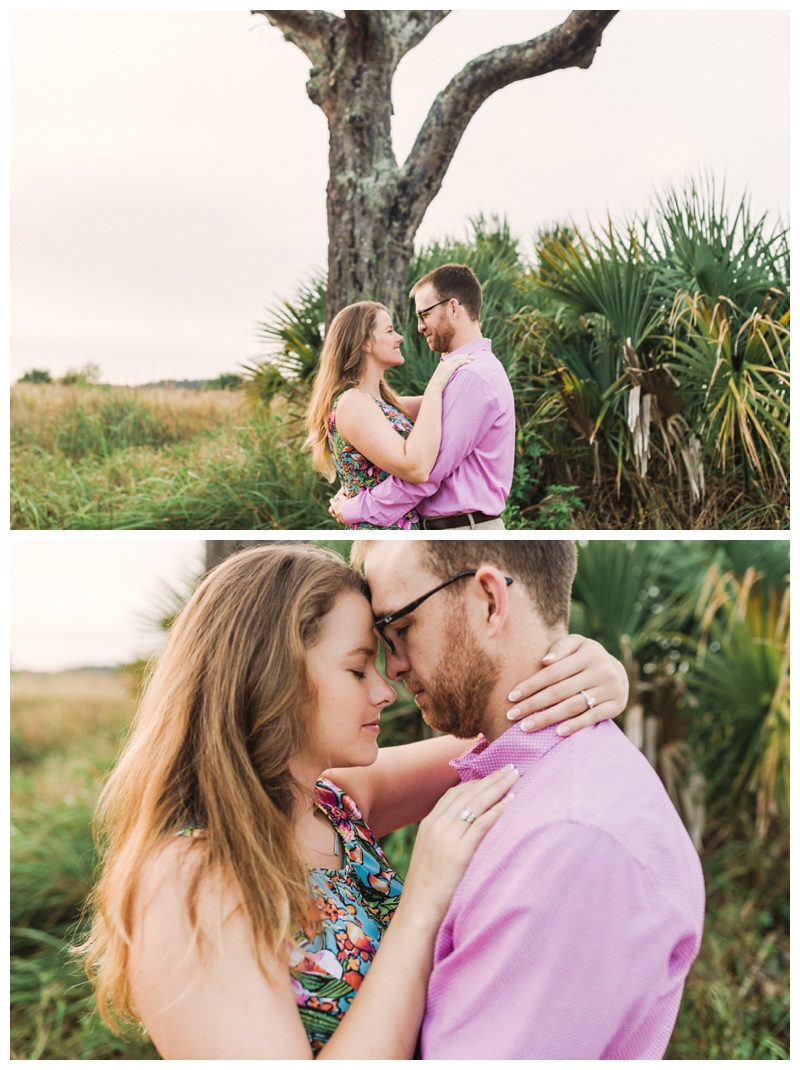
11 11 789 383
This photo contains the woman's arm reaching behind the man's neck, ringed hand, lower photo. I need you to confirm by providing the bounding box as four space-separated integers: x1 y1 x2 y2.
329 636 628 837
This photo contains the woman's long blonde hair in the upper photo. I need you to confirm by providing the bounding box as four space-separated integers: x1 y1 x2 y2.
303 301 407 483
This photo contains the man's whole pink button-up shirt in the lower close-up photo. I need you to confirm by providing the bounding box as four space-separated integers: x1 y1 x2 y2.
421 721 705 1059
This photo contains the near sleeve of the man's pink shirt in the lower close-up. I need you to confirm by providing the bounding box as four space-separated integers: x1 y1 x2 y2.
422 823 696 1059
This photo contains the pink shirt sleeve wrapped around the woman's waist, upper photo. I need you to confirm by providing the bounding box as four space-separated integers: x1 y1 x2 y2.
341 365 498 528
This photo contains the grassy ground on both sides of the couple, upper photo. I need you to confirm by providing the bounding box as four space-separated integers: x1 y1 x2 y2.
10 383 787 532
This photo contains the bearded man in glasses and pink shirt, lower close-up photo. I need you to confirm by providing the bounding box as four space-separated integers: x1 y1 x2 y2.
359 539 705 1059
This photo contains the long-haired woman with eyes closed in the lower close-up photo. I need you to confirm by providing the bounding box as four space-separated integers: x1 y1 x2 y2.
79 544 625 1059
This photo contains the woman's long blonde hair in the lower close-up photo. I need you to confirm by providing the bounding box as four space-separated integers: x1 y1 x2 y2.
78 546 367 1028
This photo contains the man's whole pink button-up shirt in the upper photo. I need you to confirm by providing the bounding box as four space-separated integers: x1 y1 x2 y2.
342 338 516 528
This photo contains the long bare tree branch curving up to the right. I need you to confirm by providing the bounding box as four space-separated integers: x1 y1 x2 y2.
399 11 617 234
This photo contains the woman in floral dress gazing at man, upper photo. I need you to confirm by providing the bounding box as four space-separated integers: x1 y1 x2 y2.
306 301 472 530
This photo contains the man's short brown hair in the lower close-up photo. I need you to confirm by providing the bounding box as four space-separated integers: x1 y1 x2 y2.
422 539 578 628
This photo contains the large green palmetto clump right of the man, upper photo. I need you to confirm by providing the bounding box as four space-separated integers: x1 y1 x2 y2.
518 183 789 517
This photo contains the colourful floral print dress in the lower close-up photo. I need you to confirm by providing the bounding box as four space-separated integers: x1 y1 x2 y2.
290 779 402 1054
